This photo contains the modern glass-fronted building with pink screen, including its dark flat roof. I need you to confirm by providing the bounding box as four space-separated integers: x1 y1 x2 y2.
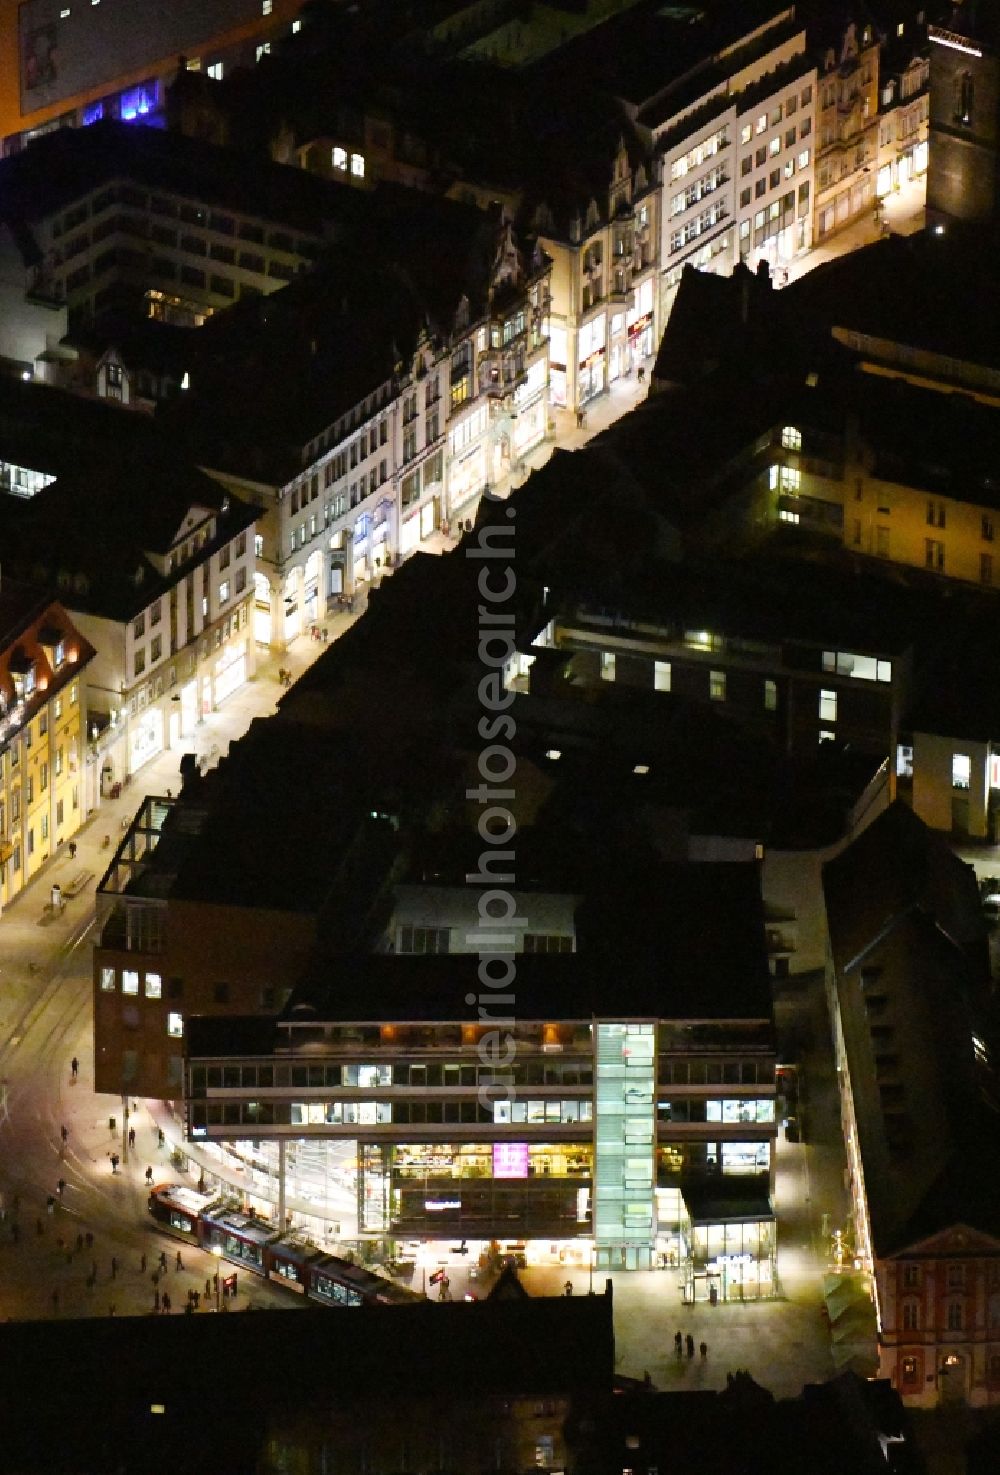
184 864 776 1299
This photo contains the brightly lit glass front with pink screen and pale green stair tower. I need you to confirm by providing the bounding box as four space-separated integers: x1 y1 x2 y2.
184 1003 776 1299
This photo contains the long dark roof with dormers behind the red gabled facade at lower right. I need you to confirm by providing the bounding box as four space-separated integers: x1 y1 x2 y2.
823 801 1000 1255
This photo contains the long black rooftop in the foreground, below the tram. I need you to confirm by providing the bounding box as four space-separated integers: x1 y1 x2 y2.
0 1303 614 1475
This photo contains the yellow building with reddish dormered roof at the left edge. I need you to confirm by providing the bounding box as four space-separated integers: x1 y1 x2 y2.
0 583 94 906
